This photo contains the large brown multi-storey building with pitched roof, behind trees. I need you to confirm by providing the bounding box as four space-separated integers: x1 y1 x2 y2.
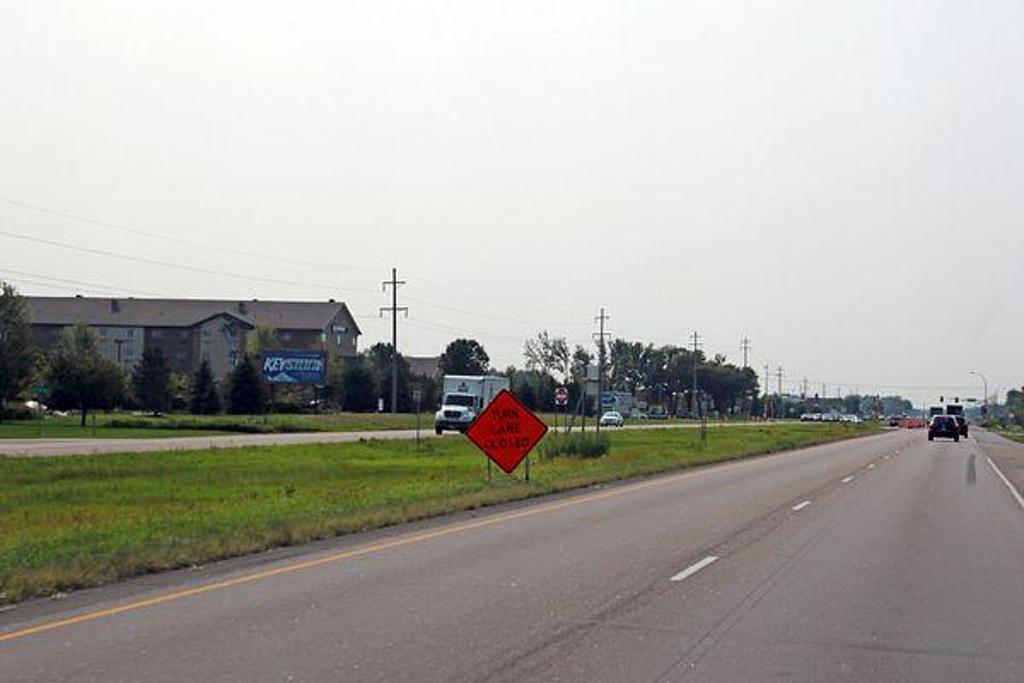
25 296 361 377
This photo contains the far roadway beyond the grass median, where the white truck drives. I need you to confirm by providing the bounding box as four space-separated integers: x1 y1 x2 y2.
0 421 786 457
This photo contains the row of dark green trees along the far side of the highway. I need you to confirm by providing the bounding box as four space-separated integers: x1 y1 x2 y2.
0 283 925 424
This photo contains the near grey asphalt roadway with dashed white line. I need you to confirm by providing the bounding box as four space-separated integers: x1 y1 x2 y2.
0 432 1024 682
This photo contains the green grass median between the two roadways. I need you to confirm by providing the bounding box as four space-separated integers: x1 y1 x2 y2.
0 424 878 602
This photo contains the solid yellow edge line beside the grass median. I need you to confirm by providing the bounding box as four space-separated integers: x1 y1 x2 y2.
0 438 847 643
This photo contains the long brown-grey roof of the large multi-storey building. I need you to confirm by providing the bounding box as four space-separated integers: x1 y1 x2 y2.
25 296 362 335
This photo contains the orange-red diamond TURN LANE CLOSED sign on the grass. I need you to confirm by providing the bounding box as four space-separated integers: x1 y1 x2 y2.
466 389 548 474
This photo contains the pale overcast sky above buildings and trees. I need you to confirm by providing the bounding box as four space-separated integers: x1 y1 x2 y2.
0 0 1024 402
